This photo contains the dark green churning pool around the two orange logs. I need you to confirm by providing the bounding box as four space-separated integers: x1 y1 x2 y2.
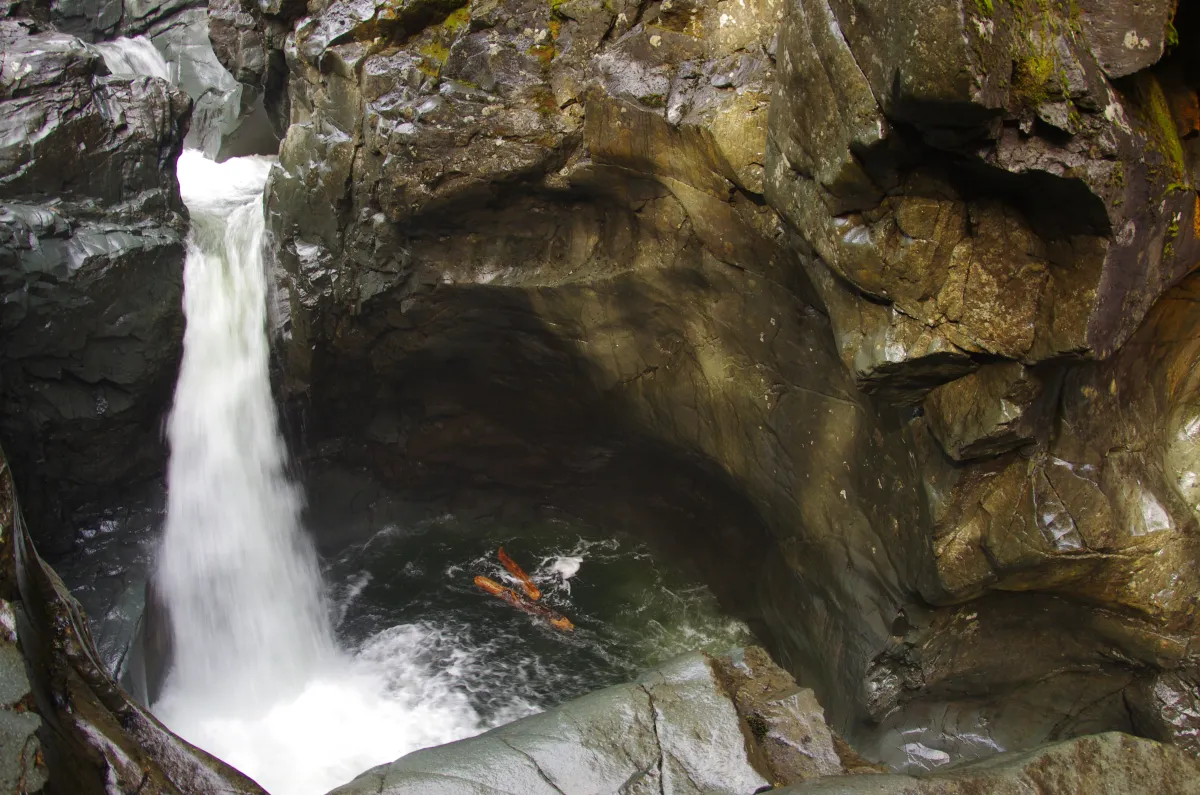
325 516 752 725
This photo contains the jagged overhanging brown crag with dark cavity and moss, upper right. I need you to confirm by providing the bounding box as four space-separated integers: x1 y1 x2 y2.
767 0 1198 400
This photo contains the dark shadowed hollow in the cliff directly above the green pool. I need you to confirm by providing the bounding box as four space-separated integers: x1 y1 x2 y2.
282 277 775 658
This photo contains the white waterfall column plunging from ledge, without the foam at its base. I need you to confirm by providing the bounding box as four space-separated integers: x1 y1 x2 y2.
157 150 334 712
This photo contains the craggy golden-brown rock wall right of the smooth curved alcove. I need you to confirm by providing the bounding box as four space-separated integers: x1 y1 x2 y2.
766 0 1198 765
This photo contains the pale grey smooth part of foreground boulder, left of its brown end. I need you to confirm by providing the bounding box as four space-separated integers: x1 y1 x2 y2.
330 653 768 795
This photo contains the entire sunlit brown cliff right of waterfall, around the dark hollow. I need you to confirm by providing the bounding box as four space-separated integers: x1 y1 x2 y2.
229 0 1200 769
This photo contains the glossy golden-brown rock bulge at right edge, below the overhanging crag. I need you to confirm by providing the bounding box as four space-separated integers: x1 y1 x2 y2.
907 275 1200 751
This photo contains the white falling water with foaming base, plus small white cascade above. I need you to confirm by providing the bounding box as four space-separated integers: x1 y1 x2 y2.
101 40 482 795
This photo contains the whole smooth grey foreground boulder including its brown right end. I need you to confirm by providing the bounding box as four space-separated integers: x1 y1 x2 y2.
330 648 857 795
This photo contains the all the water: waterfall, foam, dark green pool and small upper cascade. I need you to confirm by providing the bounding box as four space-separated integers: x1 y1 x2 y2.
91 40 750 795
